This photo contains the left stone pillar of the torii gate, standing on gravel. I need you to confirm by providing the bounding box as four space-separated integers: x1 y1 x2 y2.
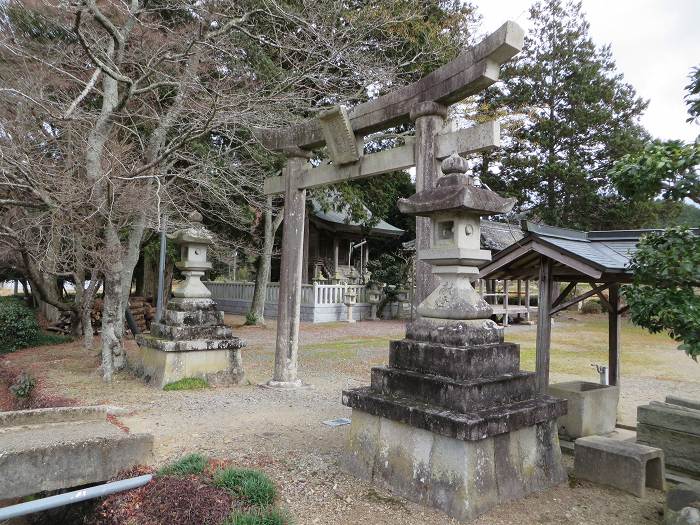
268 150 308 387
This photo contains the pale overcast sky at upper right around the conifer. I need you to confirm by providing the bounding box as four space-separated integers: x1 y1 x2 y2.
472 0 700 141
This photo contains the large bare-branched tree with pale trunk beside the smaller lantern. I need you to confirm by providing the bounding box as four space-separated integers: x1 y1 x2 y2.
0 0 424 381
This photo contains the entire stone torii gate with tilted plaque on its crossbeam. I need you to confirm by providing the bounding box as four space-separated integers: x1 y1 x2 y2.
256 22 524 388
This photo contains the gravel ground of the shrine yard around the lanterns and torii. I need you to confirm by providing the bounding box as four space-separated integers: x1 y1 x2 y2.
8 318 700 525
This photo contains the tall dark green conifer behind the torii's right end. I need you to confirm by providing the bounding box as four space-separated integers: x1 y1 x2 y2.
477 0 654 229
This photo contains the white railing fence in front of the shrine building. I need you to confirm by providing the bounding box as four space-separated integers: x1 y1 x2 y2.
204 281 369 323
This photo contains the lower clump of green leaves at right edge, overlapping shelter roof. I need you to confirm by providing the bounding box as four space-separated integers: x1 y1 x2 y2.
623 228 700 361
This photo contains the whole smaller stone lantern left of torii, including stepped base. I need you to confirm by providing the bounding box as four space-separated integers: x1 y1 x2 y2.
137 213 245 388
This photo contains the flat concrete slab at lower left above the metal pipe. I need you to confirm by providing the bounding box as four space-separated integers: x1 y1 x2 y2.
0 409 153 499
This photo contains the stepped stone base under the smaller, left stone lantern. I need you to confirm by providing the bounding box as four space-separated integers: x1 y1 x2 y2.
137 298 245 388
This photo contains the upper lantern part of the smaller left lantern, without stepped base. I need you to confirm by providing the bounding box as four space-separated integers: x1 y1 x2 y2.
172 212 213 299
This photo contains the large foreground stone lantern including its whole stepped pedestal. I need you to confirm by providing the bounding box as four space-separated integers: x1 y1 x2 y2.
343 151 566 520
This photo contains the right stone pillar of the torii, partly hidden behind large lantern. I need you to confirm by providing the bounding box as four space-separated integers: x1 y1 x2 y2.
410 102 447 305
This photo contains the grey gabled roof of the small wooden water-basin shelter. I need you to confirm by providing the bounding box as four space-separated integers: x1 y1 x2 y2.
479 221 660 282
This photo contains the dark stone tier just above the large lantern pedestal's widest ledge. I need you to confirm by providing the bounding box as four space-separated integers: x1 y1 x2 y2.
372 366 535 412
